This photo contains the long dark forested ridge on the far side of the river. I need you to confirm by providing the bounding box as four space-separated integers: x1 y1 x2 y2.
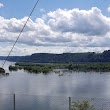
0 50 110 63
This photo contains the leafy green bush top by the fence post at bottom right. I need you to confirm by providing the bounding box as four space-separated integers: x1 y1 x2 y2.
71 100 95 110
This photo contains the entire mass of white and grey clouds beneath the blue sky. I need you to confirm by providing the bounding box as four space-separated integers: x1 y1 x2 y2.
0 7 110 54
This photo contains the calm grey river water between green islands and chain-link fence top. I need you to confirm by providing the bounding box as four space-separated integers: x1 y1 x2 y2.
0 61 110 110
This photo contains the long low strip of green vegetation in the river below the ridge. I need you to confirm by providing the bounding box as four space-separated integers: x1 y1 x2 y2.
9 63 110 73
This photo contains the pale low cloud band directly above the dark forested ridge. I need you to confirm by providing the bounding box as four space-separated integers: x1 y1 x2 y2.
0 44 110 56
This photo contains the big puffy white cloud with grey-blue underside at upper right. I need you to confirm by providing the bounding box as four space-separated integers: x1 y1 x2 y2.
48 7 110 36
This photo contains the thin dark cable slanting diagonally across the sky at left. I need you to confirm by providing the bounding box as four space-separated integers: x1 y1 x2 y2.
2 0 40 68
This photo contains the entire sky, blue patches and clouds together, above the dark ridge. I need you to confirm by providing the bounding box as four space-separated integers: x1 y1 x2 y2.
0 0 110 56
